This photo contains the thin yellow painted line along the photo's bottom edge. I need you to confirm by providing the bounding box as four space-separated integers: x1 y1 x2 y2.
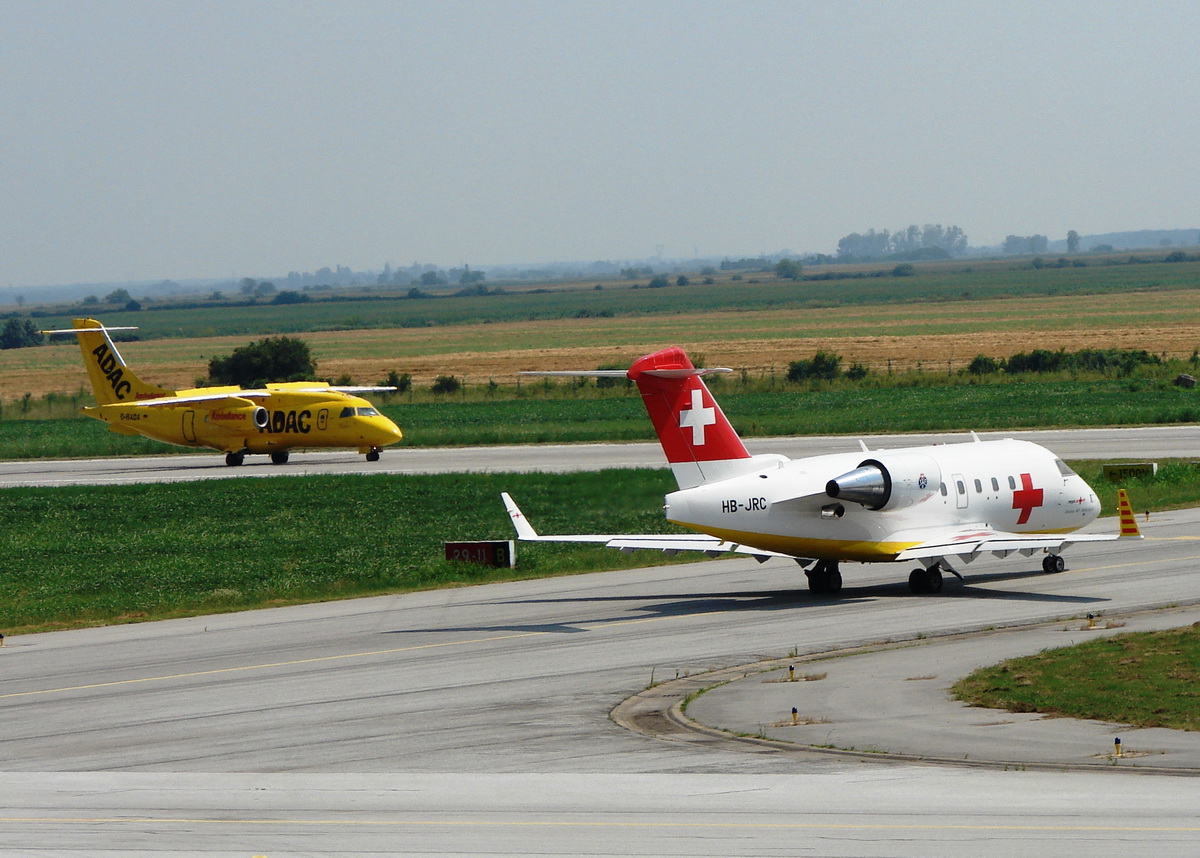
0 816 1200 834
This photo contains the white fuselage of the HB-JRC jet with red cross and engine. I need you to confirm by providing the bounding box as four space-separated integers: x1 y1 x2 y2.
666 440 1100 562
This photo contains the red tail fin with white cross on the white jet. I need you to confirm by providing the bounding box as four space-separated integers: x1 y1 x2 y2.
628 348 750 486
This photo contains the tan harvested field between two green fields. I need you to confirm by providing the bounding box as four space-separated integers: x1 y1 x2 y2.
11 290 1200 402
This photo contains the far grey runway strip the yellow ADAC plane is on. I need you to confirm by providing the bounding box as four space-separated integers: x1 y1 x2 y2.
0 425 1200 488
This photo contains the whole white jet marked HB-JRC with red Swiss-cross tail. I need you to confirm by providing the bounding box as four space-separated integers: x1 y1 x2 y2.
503 348 1141 593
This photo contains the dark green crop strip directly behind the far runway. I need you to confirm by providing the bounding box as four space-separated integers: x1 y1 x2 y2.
0 378 1200 458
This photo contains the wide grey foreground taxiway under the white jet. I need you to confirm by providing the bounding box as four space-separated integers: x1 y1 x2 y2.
0 496 1200 857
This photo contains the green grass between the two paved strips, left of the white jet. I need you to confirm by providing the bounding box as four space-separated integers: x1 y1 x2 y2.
0 469 681 634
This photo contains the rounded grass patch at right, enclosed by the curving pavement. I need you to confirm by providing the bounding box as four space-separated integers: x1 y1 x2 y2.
952 623 1200 730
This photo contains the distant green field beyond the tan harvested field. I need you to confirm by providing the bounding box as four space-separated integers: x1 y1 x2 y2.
28 253 1200 338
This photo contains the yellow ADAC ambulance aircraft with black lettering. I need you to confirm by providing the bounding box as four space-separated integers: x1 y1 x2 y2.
42 319 401 466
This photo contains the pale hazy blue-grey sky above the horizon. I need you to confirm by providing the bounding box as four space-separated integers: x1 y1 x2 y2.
0 0 1200 288
